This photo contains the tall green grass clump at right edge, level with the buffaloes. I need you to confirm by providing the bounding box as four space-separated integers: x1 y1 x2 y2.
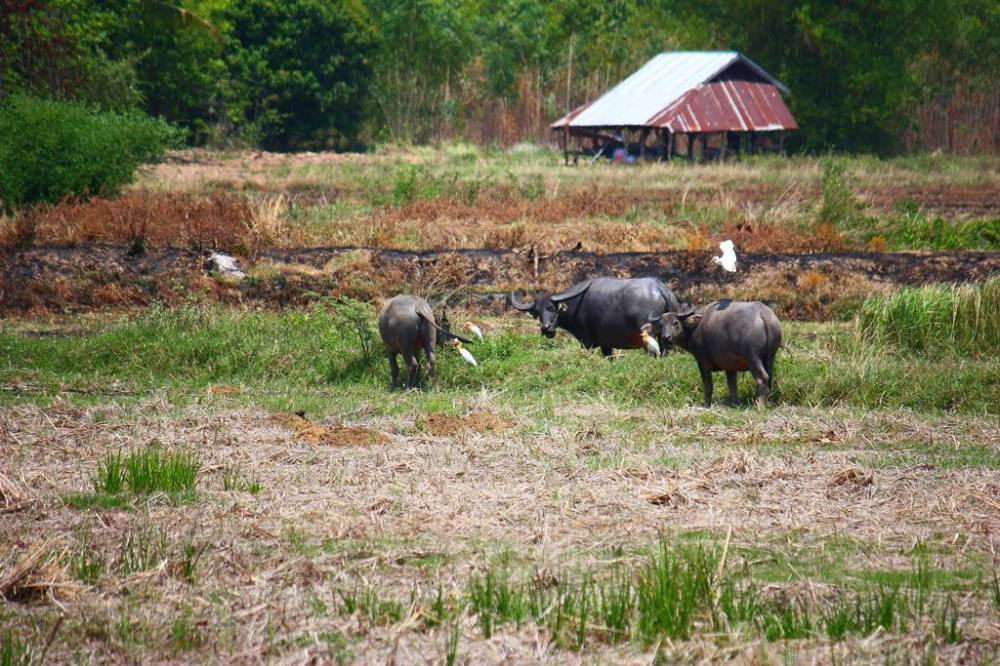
859 276 1000 355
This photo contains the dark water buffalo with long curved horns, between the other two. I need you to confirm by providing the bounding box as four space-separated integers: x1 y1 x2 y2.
510 277 679 356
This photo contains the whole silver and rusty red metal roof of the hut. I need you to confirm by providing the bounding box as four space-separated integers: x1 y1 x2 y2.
550 51 796 132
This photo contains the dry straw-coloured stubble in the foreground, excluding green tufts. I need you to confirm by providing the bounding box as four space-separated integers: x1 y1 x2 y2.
0 395 1000 663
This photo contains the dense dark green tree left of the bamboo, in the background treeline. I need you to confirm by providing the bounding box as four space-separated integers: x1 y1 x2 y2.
222 0 376 150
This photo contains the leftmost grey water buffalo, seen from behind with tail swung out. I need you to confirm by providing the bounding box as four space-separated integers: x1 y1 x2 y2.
378 294 471 388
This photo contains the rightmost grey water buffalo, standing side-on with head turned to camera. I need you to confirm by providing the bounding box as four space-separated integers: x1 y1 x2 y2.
649 300 781 407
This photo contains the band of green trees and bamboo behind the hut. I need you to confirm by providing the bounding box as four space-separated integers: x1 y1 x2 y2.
0 0 1000 154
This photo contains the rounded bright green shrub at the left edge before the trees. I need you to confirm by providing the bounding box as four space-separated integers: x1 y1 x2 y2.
0 95 178 211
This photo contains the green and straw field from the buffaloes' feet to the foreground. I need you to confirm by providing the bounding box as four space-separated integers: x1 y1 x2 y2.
0 304 1000 662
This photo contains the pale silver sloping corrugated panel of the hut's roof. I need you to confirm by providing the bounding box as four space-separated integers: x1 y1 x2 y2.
569 51 740 127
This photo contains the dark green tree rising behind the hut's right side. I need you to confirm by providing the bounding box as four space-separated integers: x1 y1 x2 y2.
694 0 951 153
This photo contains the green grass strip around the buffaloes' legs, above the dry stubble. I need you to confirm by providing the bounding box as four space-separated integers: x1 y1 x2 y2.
0 305 1000 412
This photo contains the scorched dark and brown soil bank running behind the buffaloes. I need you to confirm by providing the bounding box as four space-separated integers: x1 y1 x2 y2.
0 243 1000 319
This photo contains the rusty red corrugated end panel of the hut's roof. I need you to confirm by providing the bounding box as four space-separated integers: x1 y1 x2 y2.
648 80 798 132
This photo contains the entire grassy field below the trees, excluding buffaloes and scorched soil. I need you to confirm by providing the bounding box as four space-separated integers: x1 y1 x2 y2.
0 146 1000 666
